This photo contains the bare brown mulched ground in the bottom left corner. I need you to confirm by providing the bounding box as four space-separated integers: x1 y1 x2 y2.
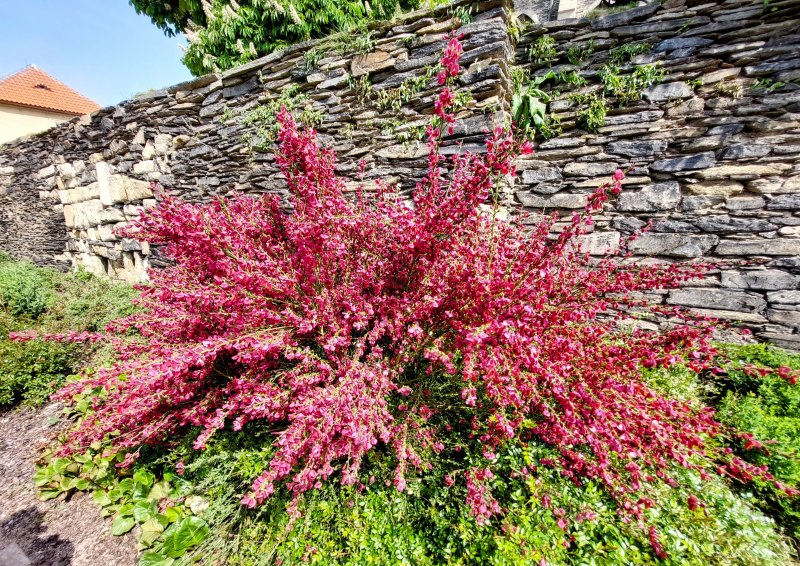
0 405 138 566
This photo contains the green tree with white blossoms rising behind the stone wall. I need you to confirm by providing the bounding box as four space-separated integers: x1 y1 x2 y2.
130 0 419 75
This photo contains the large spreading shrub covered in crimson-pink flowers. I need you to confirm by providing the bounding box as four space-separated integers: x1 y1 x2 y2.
40 38 796 554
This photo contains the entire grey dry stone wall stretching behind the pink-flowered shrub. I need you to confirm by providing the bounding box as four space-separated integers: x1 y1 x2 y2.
0 0 800 349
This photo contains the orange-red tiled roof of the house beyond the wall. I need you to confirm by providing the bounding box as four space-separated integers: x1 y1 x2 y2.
0 65 100 116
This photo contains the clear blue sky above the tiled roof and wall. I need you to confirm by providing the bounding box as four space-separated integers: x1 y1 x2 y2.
0 0 191 106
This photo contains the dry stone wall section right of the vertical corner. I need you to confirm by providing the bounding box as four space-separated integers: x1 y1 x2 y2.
517 0 800 349
